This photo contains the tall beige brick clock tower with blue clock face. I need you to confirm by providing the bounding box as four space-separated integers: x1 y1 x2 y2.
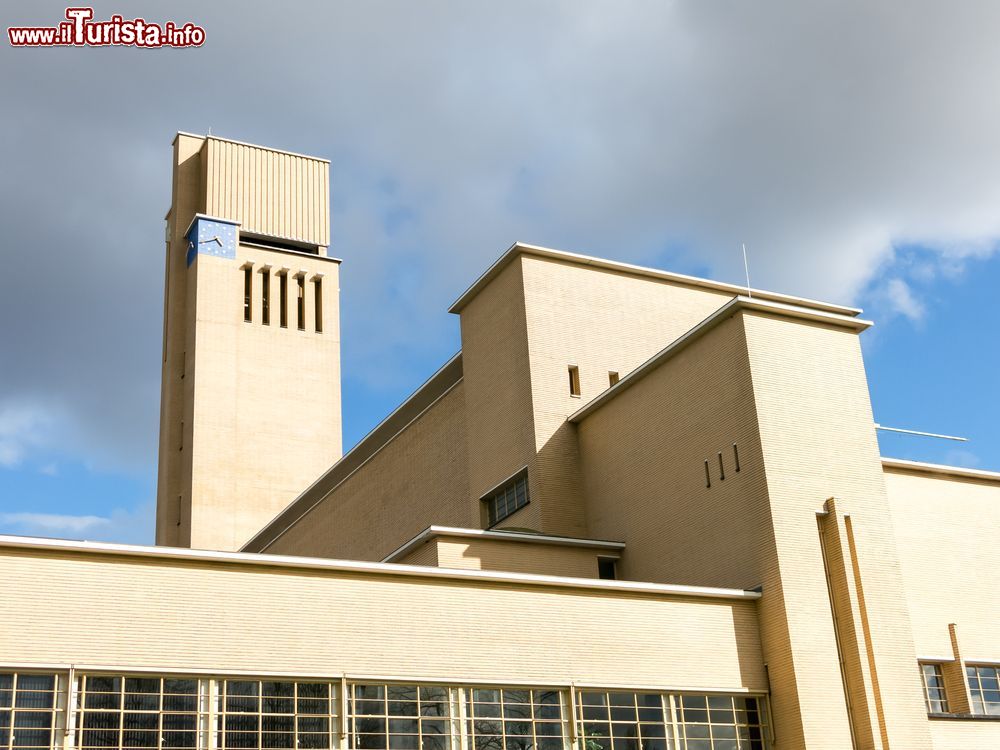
156 133 341 550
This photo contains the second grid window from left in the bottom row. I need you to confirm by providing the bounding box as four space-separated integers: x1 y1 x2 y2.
77 675 199 750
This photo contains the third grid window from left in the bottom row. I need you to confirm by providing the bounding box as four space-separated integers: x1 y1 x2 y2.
217 680 337 750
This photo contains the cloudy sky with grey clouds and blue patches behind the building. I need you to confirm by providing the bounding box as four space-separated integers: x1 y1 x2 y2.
0 0 1000 542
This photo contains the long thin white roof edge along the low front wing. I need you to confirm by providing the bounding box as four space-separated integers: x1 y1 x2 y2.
0 535 761 599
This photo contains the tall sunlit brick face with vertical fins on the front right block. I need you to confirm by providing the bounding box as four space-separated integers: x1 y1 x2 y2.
744 314 930 748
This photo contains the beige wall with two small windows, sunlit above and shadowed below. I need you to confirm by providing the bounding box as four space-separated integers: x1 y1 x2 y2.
516 254 731 536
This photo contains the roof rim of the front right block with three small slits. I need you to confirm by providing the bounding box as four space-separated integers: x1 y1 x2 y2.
569 296 873 422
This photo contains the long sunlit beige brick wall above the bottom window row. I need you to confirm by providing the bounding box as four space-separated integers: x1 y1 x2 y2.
0 548 766 690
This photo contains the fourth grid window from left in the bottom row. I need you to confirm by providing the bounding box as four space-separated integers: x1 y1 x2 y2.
351 685 451 750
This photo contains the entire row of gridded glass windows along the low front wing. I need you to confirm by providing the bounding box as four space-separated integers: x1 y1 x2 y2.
0 672 768 750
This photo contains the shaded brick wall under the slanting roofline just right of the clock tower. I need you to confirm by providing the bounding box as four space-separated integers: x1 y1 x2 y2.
267 381 479 560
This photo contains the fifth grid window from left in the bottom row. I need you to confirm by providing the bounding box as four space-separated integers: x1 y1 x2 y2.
465 688 566 750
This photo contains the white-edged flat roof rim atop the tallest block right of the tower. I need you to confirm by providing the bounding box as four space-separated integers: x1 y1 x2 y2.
448 242 862 316
